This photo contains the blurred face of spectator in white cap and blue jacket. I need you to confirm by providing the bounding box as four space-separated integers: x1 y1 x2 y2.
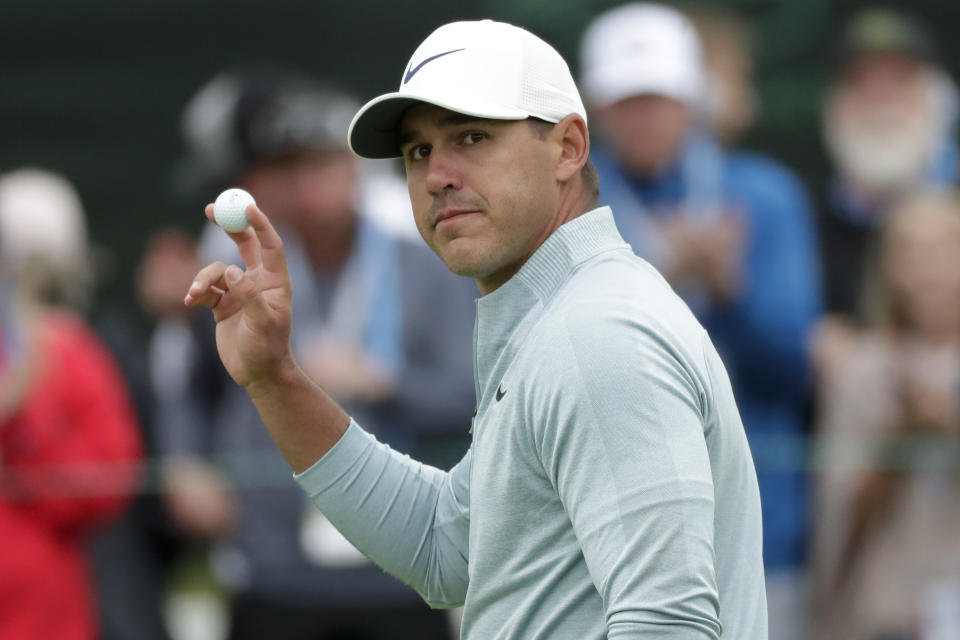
594 95 688 177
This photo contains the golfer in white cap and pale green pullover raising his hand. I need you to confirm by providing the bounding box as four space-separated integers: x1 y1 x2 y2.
185 20 766 640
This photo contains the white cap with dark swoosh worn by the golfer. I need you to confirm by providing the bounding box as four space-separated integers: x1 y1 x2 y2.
349 20 587 158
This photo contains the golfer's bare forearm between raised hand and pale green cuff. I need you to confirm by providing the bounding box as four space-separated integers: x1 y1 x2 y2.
247 360 350 473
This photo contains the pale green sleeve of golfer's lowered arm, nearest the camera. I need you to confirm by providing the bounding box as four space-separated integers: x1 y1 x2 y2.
531 318 721 640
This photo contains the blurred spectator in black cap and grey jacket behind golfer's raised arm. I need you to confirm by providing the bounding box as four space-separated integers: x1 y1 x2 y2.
163 70 476 640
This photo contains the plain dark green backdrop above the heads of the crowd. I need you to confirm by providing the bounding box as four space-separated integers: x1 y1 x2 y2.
0 0 960 304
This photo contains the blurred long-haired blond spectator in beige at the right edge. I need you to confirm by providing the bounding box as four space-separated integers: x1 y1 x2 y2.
814 193 960 640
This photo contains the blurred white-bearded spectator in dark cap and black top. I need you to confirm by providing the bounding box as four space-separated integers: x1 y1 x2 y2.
815 8 958 376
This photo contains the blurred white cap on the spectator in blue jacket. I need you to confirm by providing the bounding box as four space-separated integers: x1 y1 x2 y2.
580 3 704 106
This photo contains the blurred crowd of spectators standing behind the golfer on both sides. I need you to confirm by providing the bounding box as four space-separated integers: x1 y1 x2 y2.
0 3 960 640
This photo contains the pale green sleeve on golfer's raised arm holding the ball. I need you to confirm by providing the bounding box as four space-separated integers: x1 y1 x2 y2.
294 420 471 608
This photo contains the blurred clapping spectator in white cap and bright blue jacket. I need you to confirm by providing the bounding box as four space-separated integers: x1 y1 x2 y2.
581 4 820 638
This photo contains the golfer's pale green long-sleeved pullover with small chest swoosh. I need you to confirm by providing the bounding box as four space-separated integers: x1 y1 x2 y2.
297 208 767 640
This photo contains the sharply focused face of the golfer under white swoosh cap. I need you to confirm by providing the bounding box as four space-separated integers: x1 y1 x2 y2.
400 104 560 294
